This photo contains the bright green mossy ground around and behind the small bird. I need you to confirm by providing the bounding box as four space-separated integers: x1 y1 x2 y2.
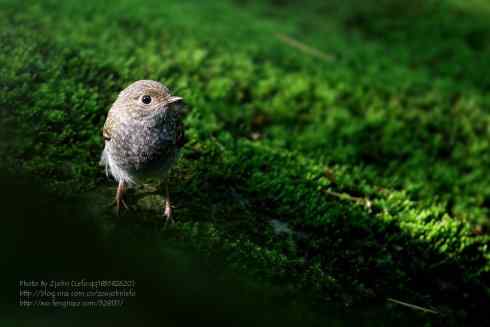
0 0 490 325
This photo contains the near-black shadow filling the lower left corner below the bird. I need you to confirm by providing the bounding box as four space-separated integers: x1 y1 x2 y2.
0 168 440 326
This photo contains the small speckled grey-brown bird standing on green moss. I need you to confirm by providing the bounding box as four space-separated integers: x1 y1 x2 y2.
100 80 185 222
